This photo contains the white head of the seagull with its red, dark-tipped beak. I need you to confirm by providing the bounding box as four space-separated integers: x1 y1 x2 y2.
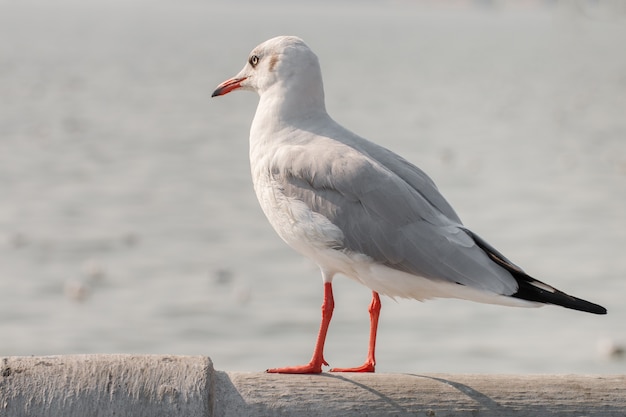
212 36 324 114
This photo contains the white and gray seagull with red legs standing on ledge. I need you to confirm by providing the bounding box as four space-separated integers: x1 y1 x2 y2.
212 36 606 374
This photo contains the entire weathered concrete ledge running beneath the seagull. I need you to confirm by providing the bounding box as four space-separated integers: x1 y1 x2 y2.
0 355 626 417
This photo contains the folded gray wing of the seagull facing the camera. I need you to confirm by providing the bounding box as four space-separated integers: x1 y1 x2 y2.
272 132 518 295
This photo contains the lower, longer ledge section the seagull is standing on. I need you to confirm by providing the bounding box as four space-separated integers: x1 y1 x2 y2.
215 372 626 417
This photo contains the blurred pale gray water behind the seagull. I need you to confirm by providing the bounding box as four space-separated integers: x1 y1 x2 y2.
0 1 626 373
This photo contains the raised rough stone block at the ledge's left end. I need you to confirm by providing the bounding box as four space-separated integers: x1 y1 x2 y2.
0 355 213 417
